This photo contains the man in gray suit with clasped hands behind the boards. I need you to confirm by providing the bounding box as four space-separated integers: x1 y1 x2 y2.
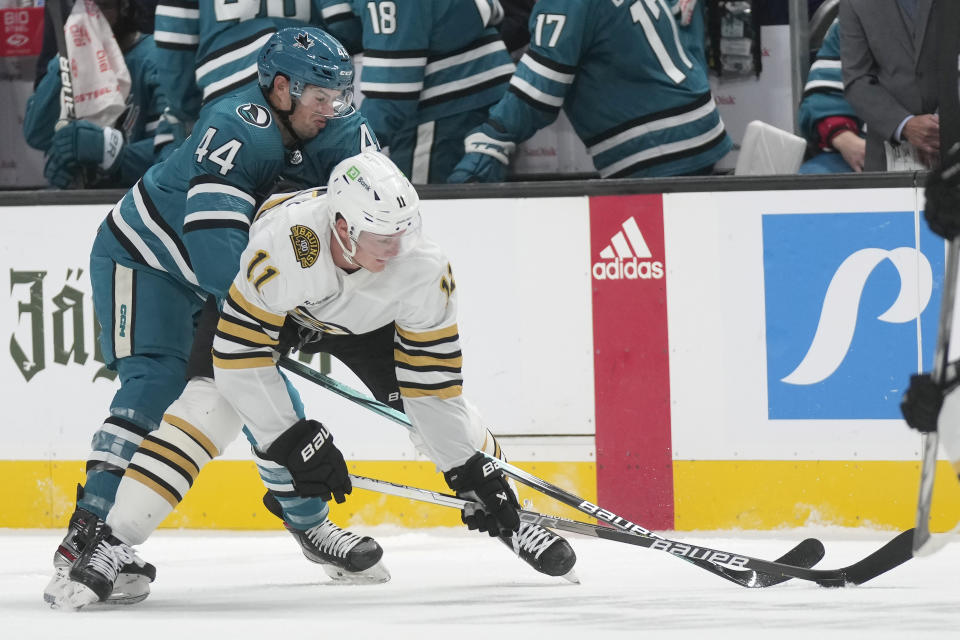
840 0 936 171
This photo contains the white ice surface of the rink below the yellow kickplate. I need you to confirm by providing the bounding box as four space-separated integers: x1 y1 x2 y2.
0 528 960 640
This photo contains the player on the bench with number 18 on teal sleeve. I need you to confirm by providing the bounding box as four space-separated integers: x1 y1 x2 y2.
330 0 514 184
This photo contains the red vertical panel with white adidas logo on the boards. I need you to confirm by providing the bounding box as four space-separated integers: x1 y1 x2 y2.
590 195 674 529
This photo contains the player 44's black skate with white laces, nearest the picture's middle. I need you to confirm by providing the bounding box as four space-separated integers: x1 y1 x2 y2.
263 491 390 584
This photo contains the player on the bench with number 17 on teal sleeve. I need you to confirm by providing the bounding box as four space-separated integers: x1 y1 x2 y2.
449 0 732 182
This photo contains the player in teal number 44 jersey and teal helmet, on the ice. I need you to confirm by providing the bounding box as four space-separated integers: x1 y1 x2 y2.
44 27 376 604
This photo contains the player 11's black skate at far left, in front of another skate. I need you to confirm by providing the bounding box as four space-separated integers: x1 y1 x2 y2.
57 522 149 609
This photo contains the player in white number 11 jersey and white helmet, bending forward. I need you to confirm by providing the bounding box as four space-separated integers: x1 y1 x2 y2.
62 151 576 607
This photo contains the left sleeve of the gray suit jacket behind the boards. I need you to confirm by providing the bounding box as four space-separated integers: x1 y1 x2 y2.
840 2 911 140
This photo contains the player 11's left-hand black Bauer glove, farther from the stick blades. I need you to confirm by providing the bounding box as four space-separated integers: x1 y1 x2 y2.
264 418 353 502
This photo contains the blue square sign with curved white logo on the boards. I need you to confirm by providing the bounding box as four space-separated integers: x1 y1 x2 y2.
763 211 944 419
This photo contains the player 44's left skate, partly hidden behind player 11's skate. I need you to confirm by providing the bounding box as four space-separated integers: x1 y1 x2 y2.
43 485 157 608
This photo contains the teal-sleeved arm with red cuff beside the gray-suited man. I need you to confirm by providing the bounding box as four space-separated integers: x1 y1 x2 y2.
797 20 867 173
